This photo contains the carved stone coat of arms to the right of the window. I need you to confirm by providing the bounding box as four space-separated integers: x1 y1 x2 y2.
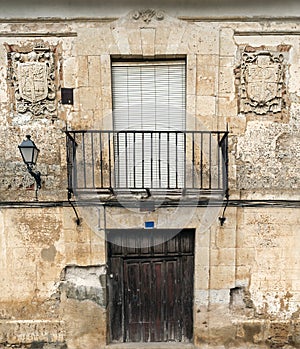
235 50 286 115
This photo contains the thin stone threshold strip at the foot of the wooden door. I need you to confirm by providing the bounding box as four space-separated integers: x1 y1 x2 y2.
104 342 196 349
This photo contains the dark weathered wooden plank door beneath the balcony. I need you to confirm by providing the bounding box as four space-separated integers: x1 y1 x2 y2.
108 229 194 342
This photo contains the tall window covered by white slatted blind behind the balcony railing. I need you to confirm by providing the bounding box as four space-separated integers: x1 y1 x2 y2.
112 60 186 189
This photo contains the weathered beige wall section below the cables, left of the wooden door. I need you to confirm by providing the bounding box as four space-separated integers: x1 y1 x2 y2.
0 208 106 348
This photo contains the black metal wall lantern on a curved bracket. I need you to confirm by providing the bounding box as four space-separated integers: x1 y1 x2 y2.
18 135 41 193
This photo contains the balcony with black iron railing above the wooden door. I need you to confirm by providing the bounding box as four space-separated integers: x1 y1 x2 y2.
66 130 228 199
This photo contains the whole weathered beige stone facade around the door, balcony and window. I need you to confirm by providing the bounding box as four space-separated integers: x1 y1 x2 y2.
0 3 300 349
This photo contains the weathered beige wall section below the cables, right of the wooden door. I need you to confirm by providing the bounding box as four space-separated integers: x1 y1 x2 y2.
195 208 299 348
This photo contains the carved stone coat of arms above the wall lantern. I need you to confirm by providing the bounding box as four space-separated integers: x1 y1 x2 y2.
8 44 56 116
